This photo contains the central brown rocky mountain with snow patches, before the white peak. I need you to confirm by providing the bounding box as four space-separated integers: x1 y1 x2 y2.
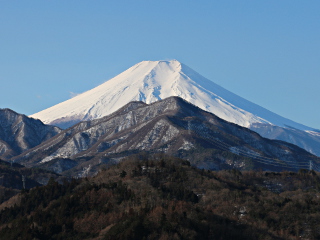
13 97 320 176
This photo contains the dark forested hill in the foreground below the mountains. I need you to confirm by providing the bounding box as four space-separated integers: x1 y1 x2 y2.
0 155 320 240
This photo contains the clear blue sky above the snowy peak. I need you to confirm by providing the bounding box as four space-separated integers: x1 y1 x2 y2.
0 0 320 129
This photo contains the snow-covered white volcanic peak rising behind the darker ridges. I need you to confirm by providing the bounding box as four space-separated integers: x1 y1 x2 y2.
31 60 320 155
